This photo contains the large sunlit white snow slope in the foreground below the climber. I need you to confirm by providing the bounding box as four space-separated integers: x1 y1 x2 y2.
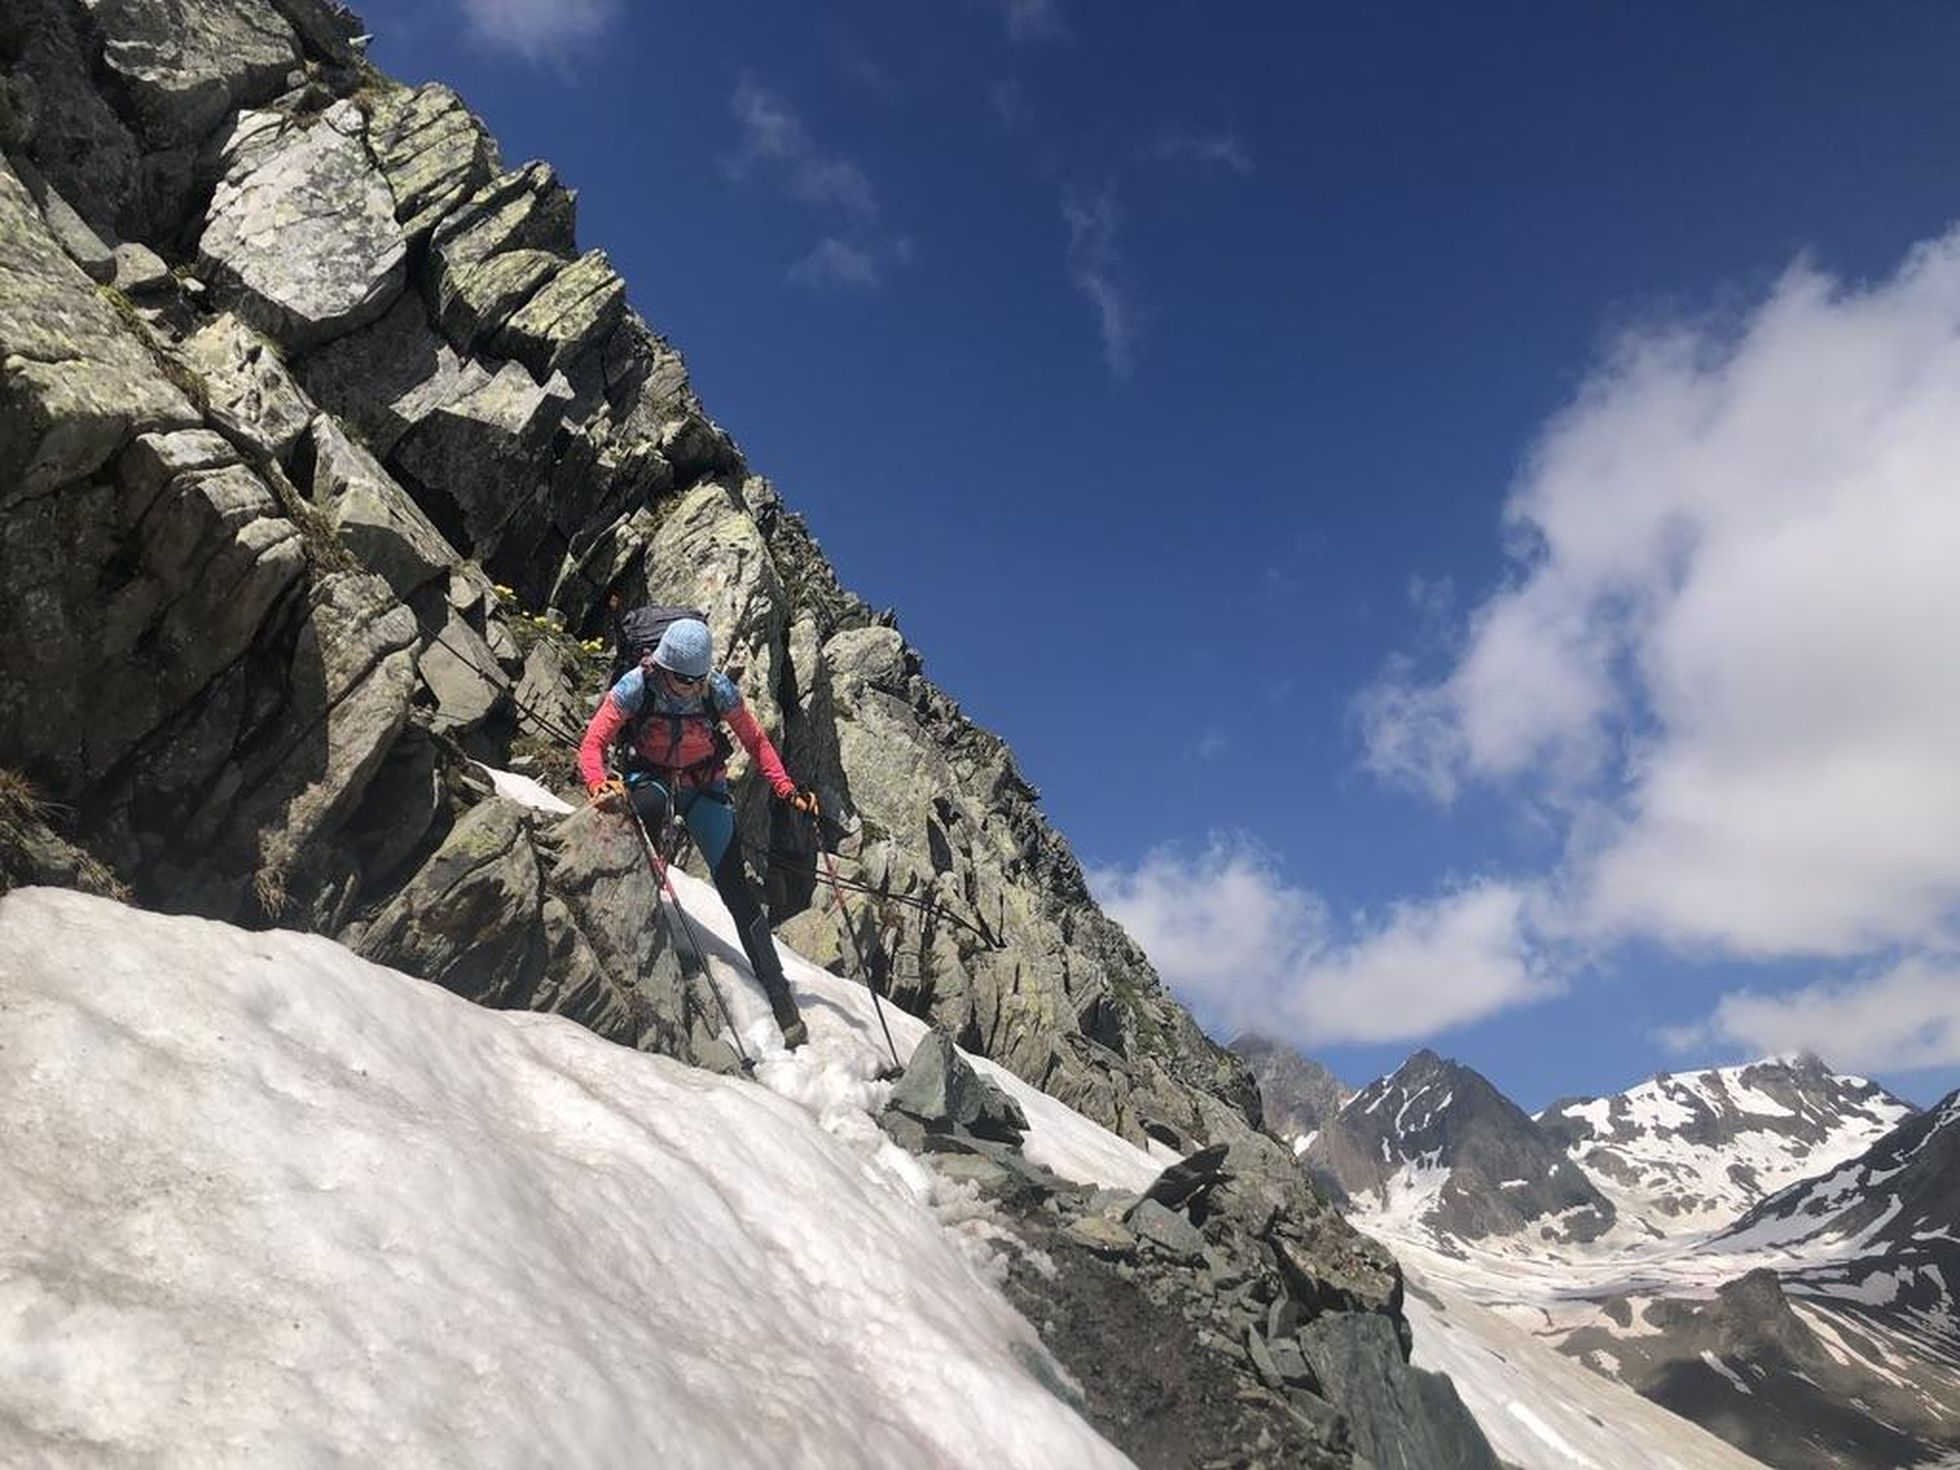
0 784 1160 1470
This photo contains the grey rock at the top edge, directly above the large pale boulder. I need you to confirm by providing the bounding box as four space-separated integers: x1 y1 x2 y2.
82 0 300 147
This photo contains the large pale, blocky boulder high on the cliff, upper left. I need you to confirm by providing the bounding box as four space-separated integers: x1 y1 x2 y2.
198 102 408 351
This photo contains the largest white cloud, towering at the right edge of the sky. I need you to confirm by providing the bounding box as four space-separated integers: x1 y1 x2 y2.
1356 233 1960 956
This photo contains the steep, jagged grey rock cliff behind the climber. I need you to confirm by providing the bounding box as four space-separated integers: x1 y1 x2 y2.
0 0 1481 1466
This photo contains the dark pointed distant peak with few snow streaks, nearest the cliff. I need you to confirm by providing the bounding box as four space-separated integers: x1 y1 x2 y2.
1305 1051 1613 1241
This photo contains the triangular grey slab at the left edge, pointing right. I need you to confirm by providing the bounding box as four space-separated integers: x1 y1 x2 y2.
0 161 198 512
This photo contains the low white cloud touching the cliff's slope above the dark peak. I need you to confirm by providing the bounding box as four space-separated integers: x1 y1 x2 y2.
1090 839 1556 1049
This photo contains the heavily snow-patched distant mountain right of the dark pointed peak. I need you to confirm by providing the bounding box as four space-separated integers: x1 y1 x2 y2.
1539 1056 1915 1235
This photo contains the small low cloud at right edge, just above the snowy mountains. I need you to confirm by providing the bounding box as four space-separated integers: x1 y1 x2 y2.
1668 956 1960 1072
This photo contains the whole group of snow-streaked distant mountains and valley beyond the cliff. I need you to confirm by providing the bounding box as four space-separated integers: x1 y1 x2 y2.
1307 1053 1960 1470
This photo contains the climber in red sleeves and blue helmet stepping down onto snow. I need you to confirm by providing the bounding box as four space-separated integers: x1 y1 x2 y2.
578 617 817 1047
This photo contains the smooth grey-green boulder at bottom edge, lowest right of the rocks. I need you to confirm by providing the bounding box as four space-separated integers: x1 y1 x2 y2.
1299 1311 1497 1470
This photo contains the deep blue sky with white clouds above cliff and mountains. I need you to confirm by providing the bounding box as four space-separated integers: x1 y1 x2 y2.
361 0 1960 1107
